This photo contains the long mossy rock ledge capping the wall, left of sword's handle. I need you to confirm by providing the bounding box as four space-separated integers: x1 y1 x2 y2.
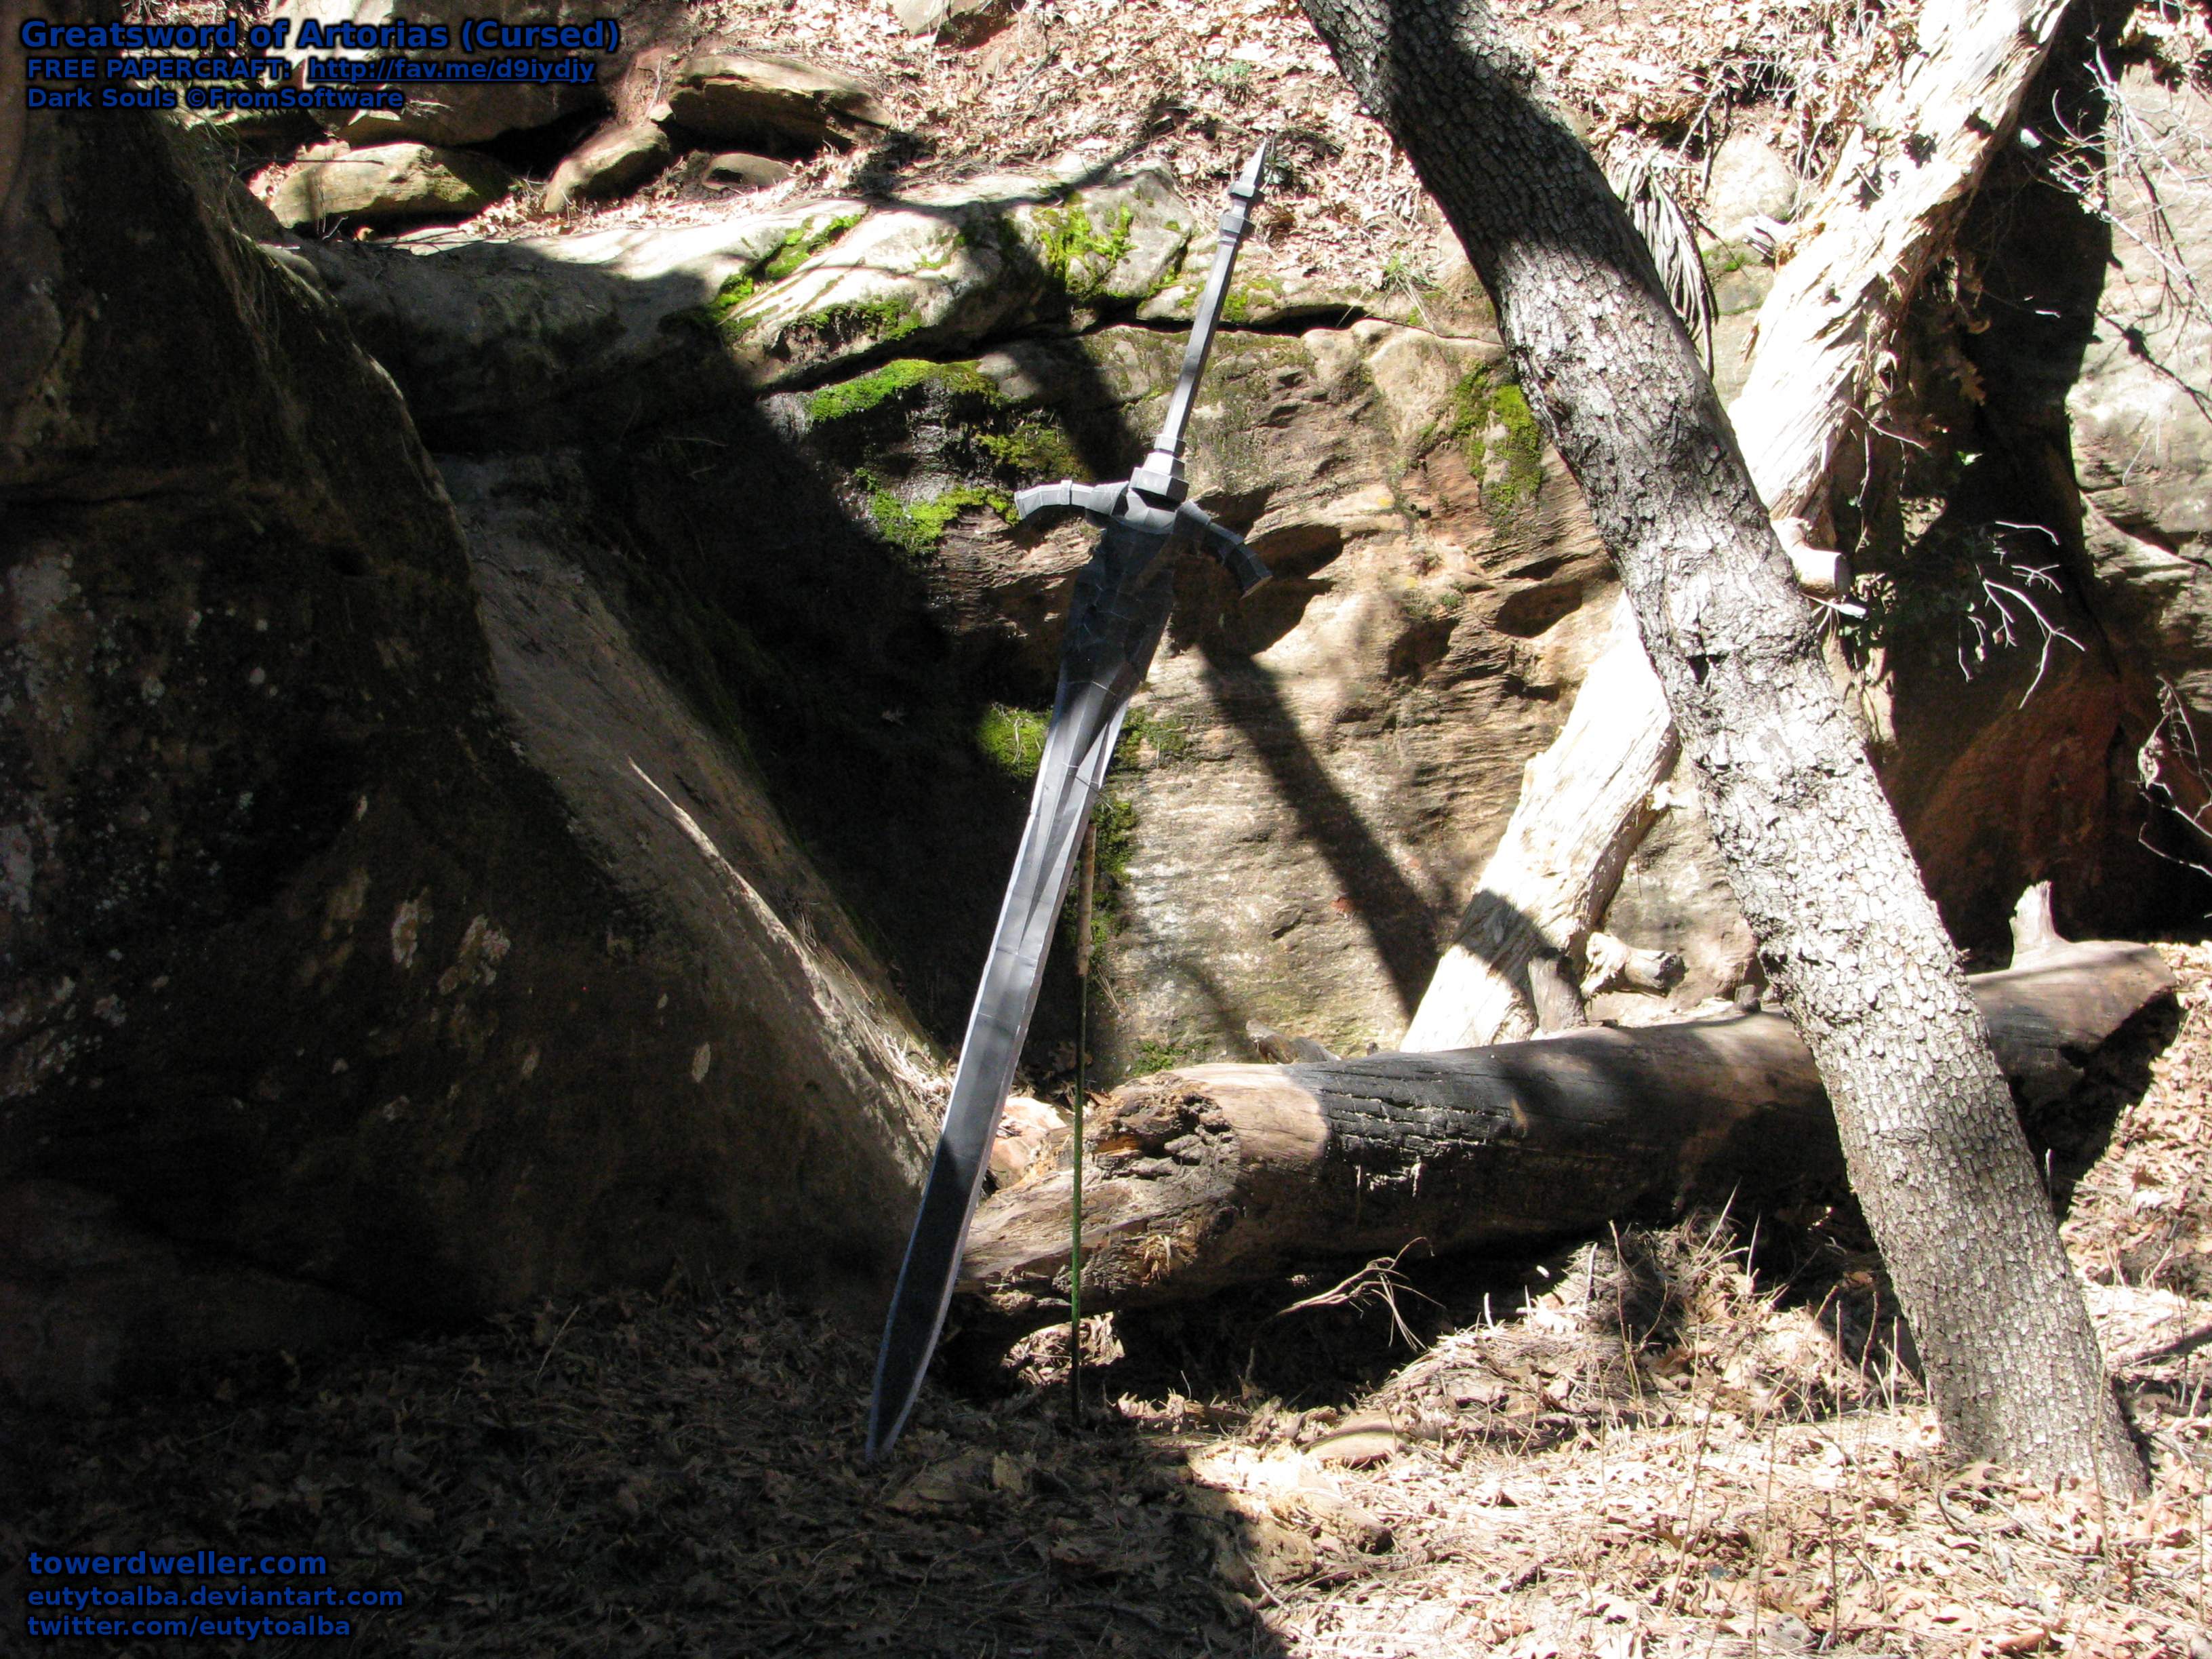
287 172 1203 447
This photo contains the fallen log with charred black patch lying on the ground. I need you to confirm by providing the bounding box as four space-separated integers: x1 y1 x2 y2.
962 936 2175 1314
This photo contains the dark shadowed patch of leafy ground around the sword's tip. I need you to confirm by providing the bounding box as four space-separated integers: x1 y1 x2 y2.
0 1287 1283 1659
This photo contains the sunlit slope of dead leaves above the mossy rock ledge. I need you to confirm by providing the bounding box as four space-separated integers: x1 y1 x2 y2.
246 0 1920 289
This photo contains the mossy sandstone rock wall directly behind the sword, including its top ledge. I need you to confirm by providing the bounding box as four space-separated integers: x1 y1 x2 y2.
289 172 1608 1071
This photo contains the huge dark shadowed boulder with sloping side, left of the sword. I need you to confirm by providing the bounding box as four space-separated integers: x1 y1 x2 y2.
0 115 933 1391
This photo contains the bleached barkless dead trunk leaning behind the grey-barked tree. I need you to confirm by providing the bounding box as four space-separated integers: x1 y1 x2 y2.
1400 0 2066 1051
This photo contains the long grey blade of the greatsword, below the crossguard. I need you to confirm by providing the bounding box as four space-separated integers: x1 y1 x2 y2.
867 527 1172 1458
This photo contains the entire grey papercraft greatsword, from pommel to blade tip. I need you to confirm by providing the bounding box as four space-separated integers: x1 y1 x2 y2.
867 144 1268 1458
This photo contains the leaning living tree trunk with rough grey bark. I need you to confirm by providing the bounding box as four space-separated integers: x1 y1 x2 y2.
1307 0 2144 1496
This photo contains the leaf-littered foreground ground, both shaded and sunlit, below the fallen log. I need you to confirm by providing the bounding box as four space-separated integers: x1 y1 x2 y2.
0 946 2212 1659
